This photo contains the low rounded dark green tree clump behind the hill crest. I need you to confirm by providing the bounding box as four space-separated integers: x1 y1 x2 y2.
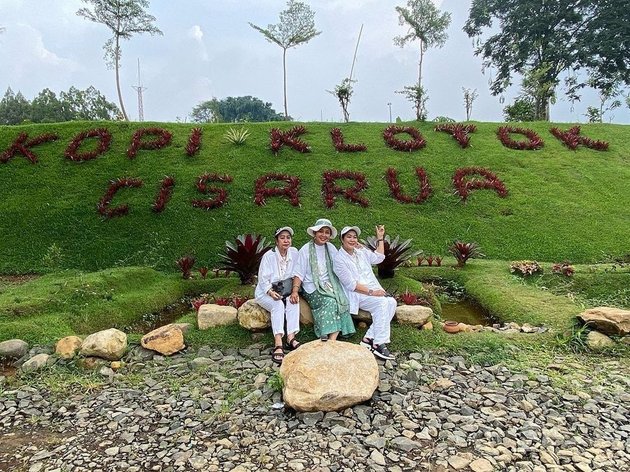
190 95 290 123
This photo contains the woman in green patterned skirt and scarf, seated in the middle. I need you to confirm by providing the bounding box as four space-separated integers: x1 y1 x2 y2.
291 218 355 341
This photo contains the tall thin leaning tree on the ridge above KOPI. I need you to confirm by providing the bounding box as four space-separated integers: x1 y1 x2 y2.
77 0 162 121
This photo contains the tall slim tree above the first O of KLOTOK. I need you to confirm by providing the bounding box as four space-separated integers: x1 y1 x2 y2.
394 0 451 120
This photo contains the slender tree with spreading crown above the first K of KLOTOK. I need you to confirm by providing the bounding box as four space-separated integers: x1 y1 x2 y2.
249 0 321 119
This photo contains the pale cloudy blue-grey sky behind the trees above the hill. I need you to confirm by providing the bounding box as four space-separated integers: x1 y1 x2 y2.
0 0 630 123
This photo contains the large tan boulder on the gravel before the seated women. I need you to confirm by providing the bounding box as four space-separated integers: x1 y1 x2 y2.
280 340 379 411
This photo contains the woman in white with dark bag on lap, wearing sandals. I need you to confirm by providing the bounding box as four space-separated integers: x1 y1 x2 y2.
255 226 300 365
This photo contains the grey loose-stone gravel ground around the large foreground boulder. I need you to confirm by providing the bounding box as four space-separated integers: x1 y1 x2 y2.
0 346 630 472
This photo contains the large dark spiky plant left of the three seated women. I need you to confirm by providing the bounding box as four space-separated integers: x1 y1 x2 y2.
219 234 271 285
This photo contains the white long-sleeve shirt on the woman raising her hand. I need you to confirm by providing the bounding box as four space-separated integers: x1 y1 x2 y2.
333 248 385 314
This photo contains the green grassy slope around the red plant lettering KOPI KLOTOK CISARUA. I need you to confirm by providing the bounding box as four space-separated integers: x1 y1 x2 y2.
0 122 630 273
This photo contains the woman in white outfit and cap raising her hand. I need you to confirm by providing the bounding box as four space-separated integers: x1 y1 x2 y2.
334 225 396 360
